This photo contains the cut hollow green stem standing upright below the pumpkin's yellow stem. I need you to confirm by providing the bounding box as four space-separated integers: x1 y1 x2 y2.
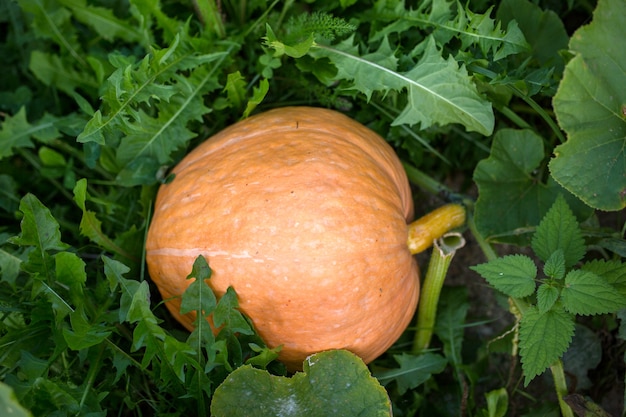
413 233 465 354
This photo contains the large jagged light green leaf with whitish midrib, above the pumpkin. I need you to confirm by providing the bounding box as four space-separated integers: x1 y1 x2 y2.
309 37 494 135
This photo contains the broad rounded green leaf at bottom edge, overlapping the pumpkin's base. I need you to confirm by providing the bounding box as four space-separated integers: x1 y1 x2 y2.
211 350 391 417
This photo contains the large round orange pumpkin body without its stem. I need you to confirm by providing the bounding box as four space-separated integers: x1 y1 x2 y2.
146 107 419 371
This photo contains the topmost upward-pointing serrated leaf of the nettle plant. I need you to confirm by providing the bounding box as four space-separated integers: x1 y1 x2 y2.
532 195 586 269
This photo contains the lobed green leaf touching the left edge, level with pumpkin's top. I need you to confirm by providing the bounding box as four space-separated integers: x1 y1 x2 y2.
0 107 61 160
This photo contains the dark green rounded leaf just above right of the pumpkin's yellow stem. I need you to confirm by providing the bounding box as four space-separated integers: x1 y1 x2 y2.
474 129 591 242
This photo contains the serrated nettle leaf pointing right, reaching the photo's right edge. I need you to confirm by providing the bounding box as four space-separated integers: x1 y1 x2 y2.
561 270 626 316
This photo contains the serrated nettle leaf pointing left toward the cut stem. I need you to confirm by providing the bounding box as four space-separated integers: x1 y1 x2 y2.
470 255 537 298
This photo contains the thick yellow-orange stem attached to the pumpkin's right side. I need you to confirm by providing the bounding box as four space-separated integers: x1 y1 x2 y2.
407 203 465 255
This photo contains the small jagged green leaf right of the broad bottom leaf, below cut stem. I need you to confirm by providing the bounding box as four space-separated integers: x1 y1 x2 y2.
374 353 448 395
